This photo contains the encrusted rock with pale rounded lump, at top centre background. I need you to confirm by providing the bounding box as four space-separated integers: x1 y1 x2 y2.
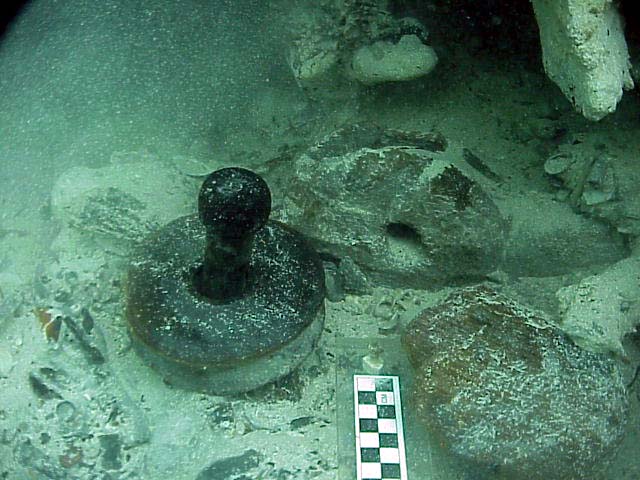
285 0 437 95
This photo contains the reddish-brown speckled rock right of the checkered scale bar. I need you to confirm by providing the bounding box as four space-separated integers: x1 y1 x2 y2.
403 287 627 480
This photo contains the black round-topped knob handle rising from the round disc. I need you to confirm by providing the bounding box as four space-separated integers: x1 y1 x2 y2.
195 167 271 303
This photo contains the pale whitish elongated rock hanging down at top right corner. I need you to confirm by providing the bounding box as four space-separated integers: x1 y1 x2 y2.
532 0 633 120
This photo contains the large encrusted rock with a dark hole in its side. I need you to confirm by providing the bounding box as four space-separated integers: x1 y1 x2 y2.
278 125 507 288
